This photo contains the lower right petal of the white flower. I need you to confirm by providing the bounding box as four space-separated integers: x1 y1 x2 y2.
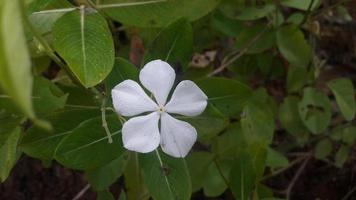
161 113 197 158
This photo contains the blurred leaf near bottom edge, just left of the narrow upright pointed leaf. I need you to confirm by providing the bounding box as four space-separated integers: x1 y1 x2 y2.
203 161 231 197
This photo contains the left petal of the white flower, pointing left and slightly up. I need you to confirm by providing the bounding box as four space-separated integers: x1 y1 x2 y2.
111 80 157 116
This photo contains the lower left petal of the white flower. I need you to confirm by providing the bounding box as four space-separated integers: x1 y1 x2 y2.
122 112 160 153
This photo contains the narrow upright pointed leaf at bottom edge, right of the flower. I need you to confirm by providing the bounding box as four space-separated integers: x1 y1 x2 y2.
230 152 256 200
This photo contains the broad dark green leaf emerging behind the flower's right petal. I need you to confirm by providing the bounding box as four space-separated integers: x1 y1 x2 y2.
197 77 251 118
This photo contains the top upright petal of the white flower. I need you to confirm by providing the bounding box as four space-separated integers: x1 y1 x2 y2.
140 60 176 105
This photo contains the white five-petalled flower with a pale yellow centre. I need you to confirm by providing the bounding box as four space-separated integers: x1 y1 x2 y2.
111 60 208 157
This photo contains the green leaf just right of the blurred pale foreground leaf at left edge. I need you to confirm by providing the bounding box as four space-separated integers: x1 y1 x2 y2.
33 77 68 113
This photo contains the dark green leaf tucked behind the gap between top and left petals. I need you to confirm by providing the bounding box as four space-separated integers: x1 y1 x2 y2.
106 58 138 93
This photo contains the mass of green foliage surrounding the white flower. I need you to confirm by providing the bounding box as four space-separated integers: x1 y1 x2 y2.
0 0 356 200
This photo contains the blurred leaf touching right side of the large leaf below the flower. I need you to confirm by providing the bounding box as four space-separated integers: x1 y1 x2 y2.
187 151 213 192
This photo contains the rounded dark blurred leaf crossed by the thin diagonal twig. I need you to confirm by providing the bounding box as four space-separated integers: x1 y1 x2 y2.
236 24 276 53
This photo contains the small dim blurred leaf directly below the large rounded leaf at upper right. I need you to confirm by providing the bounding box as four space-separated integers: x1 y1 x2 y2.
287 66 308 93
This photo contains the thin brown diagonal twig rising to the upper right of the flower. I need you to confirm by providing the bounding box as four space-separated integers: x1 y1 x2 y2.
208 24 269 77
